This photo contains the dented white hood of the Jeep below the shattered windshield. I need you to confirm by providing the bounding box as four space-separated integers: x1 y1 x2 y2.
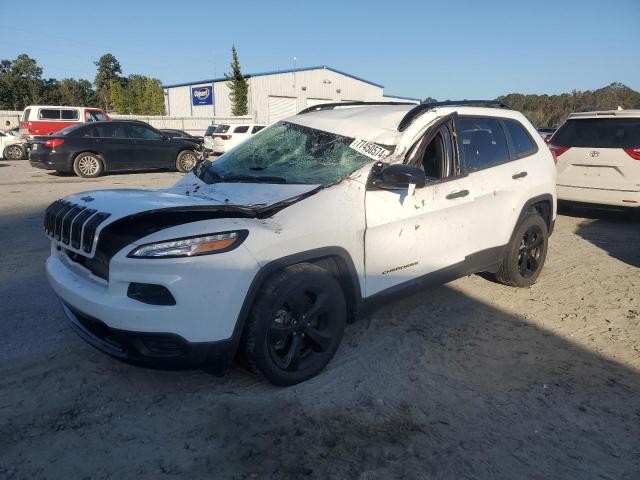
65 173 319 223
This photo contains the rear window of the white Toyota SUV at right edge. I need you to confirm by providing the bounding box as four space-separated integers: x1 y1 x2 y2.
551 118 640 148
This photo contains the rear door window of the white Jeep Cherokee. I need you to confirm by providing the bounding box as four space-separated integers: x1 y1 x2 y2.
458 117 510 173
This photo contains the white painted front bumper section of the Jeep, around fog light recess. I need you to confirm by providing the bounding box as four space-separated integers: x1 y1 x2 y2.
46 243 258 343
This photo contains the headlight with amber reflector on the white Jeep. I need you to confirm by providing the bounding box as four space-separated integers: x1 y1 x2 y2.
128 230 249 258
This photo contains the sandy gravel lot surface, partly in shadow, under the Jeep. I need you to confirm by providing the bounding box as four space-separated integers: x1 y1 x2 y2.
0 161 640 479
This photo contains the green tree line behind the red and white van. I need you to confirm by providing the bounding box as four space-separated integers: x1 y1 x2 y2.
0 53 165 115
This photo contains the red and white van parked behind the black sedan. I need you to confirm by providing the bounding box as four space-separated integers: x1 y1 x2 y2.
20 105 110 137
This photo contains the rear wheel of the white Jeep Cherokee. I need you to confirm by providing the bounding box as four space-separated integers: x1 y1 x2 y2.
495 212 549 287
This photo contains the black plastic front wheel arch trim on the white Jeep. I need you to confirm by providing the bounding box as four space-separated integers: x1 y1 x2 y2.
232 247 364 358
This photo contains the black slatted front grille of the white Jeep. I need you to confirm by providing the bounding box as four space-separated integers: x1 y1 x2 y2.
44 200 110 253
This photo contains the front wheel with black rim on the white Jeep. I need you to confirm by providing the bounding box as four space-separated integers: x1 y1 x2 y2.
241 263 347 386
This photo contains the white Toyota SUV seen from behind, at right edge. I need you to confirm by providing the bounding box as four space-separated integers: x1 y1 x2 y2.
549 110 640 208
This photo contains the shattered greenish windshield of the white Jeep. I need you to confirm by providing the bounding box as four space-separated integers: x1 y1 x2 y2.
198 122 382 185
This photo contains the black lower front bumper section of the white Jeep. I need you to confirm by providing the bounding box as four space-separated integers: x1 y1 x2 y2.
61 302 237 370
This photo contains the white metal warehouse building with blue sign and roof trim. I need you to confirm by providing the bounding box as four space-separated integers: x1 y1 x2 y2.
163 65 420 124
